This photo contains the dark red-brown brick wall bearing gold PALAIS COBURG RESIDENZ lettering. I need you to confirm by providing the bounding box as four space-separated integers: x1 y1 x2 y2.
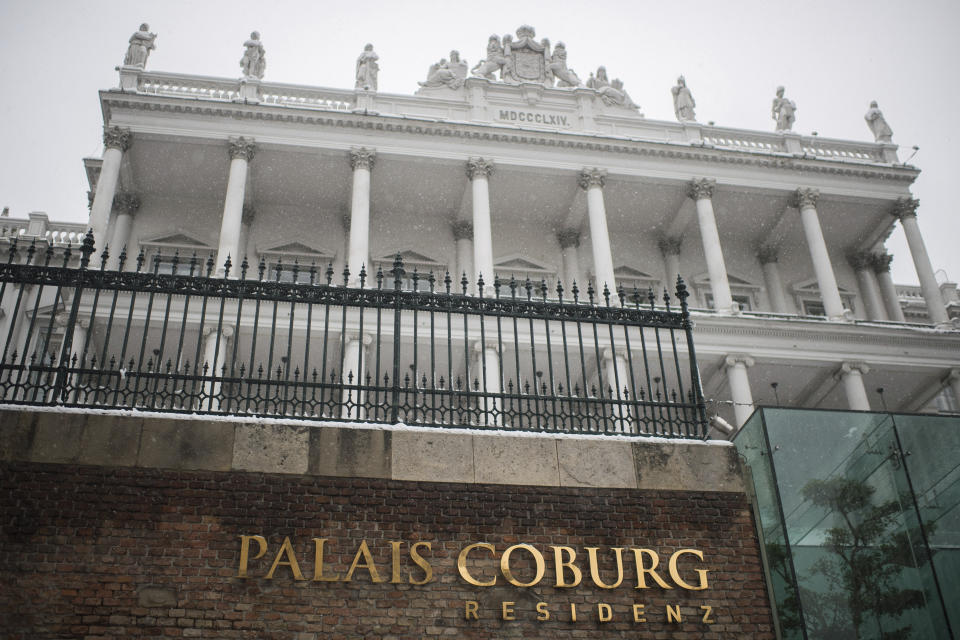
0 462 773 640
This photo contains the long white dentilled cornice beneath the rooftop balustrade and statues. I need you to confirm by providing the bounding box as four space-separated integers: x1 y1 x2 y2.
101 91 920 184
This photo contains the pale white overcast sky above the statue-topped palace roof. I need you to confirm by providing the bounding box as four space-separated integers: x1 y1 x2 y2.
0 0 960 283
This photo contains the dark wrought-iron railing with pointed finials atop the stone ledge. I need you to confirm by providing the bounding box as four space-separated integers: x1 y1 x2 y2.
0 233 706 438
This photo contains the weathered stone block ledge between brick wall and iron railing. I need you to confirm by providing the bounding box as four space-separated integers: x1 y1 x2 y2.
0 407 745 493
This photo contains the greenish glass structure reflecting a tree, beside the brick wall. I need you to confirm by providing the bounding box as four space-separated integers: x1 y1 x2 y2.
734 408 960 640
